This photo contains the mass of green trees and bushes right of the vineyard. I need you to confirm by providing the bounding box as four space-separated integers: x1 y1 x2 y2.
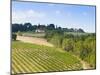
45 30 96 68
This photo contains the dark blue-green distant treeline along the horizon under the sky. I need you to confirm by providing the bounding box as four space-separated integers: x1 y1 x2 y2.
12 23 84 33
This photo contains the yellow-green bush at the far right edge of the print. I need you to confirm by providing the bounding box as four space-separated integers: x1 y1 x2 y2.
84 36 96 68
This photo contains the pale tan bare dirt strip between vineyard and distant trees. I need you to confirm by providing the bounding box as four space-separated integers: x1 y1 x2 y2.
17 36 53 47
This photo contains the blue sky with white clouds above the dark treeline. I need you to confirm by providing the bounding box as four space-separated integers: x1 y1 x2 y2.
12 1 96 32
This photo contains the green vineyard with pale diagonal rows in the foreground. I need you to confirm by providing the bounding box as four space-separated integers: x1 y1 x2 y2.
12 41 82 74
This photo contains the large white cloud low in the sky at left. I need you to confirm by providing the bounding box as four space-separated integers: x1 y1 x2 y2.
12 9 46 22
